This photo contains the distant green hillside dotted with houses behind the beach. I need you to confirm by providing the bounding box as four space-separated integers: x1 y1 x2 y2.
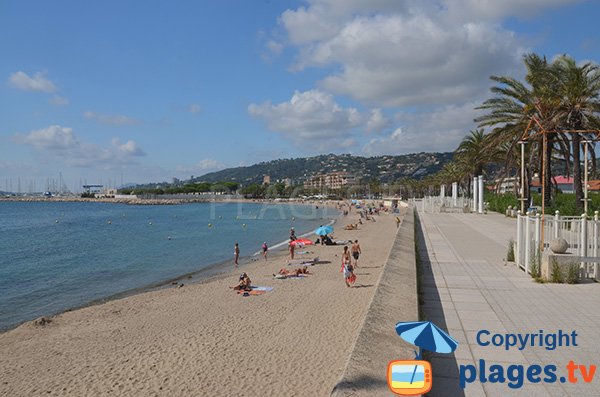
190 152 453 185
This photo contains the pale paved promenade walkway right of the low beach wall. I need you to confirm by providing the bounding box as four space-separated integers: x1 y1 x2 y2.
417 213 600 397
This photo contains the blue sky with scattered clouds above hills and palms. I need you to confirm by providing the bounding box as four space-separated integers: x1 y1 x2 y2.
0 0 600 192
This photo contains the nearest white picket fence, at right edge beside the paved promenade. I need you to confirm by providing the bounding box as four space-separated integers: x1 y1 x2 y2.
515 211 600 279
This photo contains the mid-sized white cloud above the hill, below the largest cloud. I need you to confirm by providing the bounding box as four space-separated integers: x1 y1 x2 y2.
248 90 363 150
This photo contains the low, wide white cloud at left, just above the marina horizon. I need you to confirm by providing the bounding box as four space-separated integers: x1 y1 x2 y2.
12 125 145 168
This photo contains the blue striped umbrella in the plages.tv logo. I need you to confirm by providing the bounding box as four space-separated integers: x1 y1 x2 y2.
396 321 458 359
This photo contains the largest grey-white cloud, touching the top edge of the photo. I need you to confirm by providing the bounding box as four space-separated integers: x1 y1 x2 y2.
279 0 580 107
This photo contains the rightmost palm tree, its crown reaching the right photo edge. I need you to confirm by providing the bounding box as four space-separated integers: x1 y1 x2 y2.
554 55 600 210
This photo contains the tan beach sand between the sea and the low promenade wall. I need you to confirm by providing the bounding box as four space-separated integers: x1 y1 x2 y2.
0 211 404 396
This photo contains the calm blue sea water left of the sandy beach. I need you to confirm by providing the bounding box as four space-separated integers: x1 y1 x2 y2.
0 202 337 329
